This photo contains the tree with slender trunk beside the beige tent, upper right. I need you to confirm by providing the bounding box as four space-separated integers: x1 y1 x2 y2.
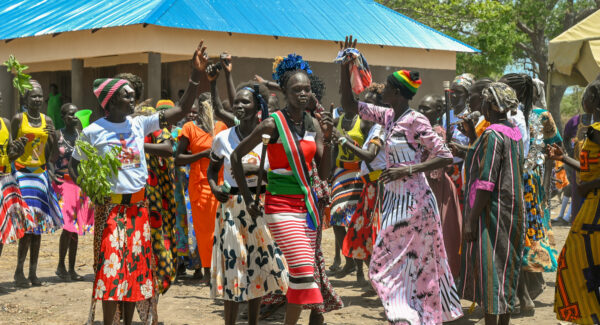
514 0 600 130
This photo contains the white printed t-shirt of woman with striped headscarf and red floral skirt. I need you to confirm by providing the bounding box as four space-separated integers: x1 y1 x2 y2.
73 114 160 194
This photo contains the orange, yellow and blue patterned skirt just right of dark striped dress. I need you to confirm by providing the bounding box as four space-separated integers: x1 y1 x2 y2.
522 171 558 272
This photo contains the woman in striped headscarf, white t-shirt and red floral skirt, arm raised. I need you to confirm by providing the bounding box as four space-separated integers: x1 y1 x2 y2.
69 42 206 324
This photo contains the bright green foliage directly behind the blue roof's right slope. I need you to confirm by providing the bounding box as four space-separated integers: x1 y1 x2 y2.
377 0 518 77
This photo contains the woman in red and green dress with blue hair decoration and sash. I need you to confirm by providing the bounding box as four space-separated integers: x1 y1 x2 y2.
231 54 333 324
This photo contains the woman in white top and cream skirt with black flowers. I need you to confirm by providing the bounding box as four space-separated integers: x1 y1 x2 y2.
207 74 288 324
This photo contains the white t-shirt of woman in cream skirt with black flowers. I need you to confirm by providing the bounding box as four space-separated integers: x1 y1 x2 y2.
212 126 269 187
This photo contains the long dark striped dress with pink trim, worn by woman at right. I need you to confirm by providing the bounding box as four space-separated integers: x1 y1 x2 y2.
457 124 525 315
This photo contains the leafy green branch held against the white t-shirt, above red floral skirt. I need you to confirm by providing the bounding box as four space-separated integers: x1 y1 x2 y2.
77 140 121 204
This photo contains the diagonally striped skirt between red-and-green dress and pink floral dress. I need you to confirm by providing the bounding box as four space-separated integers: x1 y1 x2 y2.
330 167 364 226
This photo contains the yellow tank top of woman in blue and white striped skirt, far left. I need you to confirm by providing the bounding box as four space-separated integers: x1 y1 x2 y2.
15 113 48 173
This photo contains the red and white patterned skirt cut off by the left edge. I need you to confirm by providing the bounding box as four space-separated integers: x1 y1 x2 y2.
0 174 35 244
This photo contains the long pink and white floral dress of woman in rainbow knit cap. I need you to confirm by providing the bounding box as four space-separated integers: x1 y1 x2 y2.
359 102 462 324
